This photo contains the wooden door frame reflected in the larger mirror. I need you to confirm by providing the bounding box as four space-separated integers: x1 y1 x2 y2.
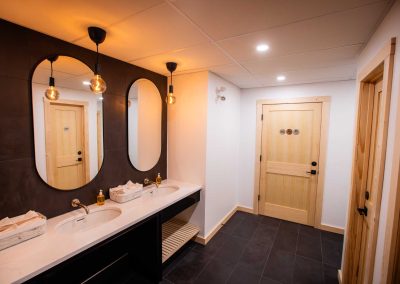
43 98 90 185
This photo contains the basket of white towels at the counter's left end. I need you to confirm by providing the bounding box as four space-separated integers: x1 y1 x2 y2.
0 210 47 250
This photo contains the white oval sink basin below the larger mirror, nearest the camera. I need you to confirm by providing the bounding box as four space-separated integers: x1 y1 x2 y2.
55 207 121 234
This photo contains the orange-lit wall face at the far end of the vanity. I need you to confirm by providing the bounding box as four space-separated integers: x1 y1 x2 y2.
167 72 208 236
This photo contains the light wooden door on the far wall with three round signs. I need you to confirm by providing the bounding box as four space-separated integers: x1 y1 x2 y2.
259 103 321 225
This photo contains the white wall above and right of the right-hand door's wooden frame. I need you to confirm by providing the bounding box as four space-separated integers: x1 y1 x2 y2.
358 1 400 283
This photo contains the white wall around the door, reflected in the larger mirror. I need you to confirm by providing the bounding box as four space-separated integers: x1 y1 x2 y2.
32 83 98 181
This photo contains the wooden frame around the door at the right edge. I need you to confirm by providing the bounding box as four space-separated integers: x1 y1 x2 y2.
342 39 397 283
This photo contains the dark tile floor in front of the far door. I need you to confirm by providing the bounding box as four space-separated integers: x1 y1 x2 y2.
162 212 343 284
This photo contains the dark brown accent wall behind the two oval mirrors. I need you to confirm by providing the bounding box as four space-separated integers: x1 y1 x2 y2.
0 19 167 218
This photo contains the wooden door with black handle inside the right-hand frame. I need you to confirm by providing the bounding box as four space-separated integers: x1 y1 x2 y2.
349 80 385 283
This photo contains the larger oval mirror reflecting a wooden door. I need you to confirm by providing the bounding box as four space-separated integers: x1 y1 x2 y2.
32 56 103 190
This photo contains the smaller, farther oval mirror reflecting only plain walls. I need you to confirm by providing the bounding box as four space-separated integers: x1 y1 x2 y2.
128 79 162 171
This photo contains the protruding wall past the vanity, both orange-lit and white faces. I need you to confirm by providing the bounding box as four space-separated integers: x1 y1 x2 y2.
168 72 240 237
